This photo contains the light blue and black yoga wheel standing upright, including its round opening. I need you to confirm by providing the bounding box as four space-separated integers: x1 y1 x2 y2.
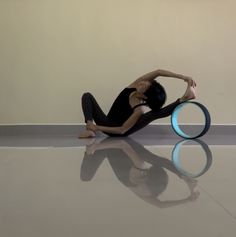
171 101 211 139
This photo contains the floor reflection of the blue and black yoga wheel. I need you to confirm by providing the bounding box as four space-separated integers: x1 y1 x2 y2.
172 139 212 178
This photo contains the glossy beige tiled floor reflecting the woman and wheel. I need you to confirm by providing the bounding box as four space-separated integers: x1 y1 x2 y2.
0 137 236 237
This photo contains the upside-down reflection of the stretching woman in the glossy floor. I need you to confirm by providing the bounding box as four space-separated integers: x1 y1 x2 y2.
81 138 199 208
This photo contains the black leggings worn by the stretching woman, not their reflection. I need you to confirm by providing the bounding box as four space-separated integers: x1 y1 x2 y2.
82 92 181 137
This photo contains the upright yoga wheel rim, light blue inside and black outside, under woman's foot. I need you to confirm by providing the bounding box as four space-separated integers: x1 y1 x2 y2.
171 101 211 139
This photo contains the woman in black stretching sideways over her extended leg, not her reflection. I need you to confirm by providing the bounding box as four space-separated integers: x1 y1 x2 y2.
79 70 196 138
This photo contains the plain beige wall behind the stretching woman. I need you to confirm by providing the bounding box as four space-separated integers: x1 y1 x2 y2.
0 0 236 124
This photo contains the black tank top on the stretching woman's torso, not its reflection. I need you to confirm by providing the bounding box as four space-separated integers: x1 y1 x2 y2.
107 87 136 126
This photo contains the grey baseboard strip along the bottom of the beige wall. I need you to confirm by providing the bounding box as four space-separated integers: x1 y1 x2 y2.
0 124 236 136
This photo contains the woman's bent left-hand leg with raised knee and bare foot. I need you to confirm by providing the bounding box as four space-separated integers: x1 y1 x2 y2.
79 92 110 138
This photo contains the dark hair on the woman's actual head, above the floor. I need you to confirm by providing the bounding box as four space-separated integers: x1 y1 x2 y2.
144 80 166 110
